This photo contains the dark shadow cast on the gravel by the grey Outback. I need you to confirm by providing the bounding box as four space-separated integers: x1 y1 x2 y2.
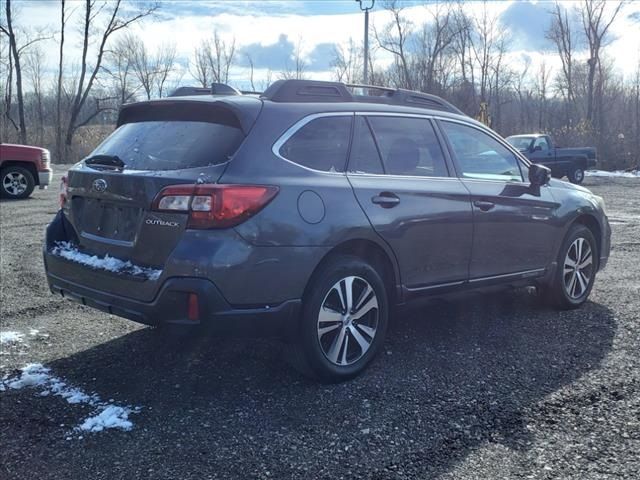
32 290 616 478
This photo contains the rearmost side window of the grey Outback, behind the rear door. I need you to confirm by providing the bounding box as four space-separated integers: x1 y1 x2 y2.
280 116 353 172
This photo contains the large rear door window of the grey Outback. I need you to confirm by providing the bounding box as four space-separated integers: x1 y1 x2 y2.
369 117 448 177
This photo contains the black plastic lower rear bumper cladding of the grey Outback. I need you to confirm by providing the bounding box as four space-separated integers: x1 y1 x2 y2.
47 272 300 334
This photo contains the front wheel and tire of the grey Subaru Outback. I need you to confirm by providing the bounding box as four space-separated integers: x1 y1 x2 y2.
544 224 599 310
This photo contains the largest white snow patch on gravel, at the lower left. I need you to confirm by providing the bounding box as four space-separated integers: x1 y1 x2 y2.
0 363 140 432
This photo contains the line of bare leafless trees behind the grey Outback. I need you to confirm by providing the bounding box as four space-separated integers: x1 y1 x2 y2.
0 0 640 168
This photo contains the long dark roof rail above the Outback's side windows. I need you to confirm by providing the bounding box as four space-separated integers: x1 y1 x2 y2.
260 80 464 115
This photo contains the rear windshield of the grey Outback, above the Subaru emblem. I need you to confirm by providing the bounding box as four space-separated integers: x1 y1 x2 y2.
90 120 244 170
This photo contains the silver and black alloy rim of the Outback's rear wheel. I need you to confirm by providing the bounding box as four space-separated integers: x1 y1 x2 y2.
317 276 379 366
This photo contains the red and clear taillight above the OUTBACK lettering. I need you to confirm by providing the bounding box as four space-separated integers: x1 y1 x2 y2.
152 184 278 228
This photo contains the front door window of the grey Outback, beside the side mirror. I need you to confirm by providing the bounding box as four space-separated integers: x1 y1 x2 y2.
442 121 522 181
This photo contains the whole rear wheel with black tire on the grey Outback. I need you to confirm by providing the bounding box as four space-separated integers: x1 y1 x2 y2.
291 255 389 383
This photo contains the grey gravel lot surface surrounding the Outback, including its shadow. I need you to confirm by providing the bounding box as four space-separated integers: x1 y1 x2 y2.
0 168 640 480
